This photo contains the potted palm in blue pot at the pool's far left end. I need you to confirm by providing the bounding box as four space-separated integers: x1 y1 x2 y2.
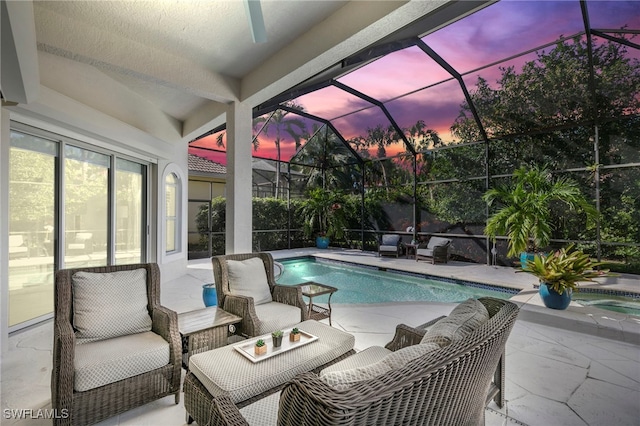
301 188 347 248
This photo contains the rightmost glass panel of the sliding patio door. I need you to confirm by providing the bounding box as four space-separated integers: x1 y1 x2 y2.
115 158 146 265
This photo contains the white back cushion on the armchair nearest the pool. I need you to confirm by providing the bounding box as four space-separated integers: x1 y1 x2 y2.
227 257 272 306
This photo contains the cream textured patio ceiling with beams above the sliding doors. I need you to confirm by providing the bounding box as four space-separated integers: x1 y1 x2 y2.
2 0 487 148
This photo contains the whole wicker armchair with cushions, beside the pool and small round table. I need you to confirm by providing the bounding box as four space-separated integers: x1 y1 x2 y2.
211 253 309 337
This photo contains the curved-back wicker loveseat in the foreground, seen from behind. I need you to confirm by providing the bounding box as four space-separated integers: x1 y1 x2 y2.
208 298 518 425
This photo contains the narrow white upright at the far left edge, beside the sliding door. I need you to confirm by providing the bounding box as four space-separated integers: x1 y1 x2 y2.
0 107 11 352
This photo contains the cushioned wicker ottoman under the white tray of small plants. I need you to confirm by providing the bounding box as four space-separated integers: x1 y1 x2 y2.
184 320 355 426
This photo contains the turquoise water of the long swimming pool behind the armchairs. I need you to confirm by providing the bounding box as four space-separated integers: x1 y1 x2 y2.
278 259 517 303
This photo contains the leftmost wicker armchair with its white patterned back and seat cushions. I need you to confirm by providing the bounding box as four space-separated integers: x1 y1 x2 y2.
51 263 182 425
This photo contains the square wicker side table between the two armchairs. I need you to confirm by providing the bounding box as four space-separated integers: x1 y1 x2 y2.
178 306 242 370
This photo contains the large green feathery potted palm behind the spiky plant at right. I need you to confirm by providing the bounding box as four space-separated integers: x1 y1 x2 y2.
483 166 596 266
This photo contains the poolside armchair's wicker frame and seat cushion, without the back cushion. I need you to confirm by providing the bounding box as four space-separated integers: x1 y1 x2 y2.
211 253 309 337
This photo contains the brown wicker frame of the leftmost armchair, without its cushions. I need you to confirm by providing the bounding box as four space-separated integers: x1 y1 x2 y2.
51 263 182 425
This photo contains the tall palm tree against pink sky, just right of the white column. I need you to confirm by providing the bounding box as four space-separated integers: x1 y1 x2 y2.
253 101 307 198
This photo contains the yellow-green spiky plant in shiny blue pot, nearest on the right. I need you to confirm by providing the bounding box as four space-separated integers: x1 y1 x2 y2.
518 244 610 309
